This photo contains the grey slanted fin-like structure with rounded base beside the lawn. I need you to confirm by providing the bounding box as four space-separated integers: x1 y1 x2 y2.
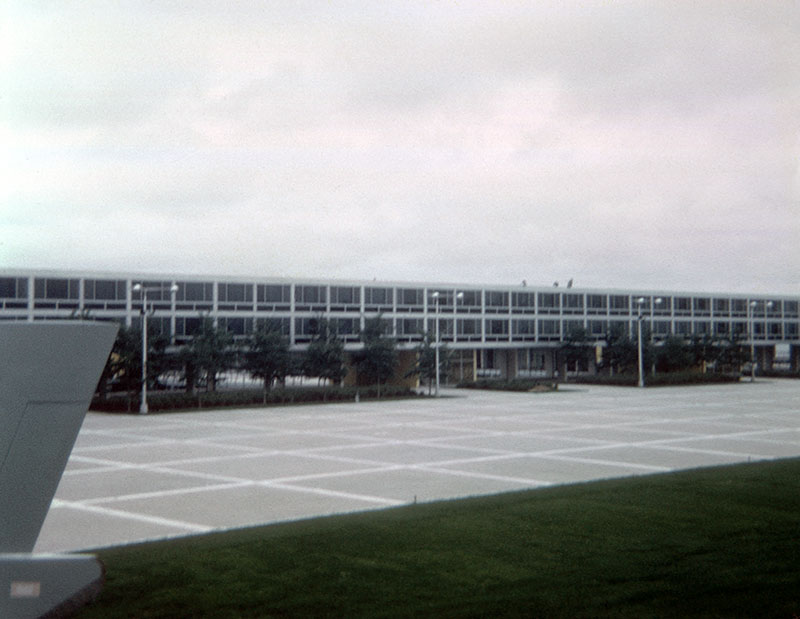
0 321 117 619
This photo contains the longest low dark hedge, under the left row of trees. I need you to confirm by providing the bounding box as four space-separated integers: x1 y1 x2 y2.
90 385 417 413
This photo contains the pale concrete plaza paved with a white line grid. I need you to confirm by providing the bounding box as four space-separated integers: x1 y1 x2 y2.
36 380 800 552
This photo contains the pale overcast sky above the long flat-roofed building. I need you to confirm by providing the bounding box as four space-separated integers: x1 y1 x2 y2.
0 0 800 294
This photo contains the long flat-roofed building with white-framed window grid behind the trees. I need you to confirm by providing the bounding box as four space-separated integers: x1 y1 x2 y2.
0 269 800 377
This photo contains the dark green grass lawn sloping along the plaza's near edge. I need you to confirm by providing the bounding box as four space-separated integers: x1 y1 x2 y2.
80 459 800 619
